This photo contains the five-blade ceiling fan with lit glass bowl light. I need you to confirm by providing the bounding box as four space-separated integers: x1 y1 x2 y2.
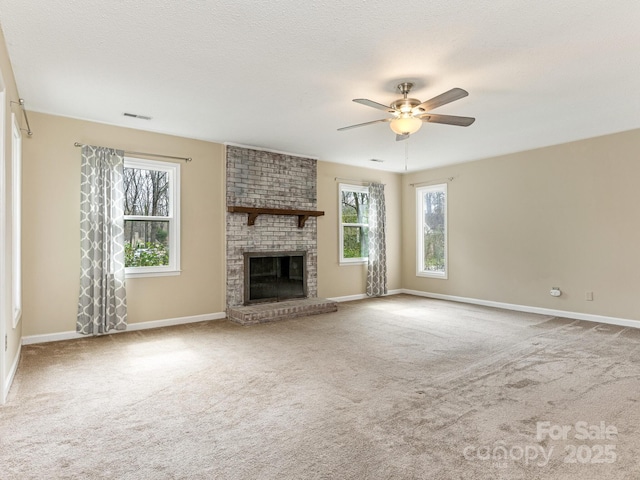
338 82 476 141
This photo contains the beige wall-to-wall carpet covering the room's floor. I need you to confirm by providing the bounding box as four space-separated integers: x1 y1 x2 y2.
0 295 640 480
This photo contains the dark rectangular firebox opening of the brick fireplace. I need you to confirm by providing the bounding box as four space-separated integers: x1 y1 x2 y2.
244 252 307 305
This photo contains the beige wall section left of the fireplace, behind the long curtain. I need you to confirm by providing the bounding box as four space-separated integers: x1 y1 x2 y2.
23 113 225 336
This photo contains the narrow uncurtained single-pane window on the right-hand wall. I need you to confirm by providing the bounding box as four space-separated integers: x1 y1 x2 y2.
416 184 447 278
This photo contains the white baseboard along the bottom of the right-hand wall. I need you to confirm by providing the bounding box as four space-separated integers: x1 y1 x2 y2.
402 289 640 328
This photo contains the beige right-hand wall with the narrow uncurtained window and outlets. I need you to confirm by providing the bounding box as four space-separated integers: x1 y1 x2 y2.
402 130 640 319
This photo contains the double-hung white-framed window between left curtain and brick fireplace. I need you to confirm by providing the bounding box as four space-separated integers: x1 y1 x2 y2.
124 157 180 277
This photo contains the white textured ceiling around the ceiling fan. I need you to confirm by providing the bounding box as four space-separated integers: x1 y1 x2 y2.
0 0 640 171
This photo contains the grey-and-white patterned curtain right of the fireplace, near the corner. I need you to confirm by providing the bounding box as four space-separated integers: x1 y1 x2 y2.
367 183 387 297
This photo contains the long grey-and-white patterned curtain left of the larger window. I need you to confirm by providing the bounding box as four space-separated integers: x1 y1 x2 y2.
76 145 127 335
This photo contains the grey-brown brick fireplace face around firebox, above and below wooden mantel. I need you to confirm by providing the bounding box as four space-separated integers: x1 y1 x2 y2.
226 145 318 311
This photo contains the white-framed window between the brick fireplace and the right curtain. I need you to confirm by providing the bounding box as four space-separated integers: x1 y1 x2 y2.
339 184 369 263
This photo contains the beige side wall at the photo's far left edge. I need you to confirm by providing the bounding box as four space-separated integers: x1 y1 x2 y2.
0 26 26 403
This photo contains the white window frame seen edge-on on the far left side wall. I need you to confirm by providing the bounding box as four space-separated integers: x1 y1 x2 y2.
11 113 22 328
